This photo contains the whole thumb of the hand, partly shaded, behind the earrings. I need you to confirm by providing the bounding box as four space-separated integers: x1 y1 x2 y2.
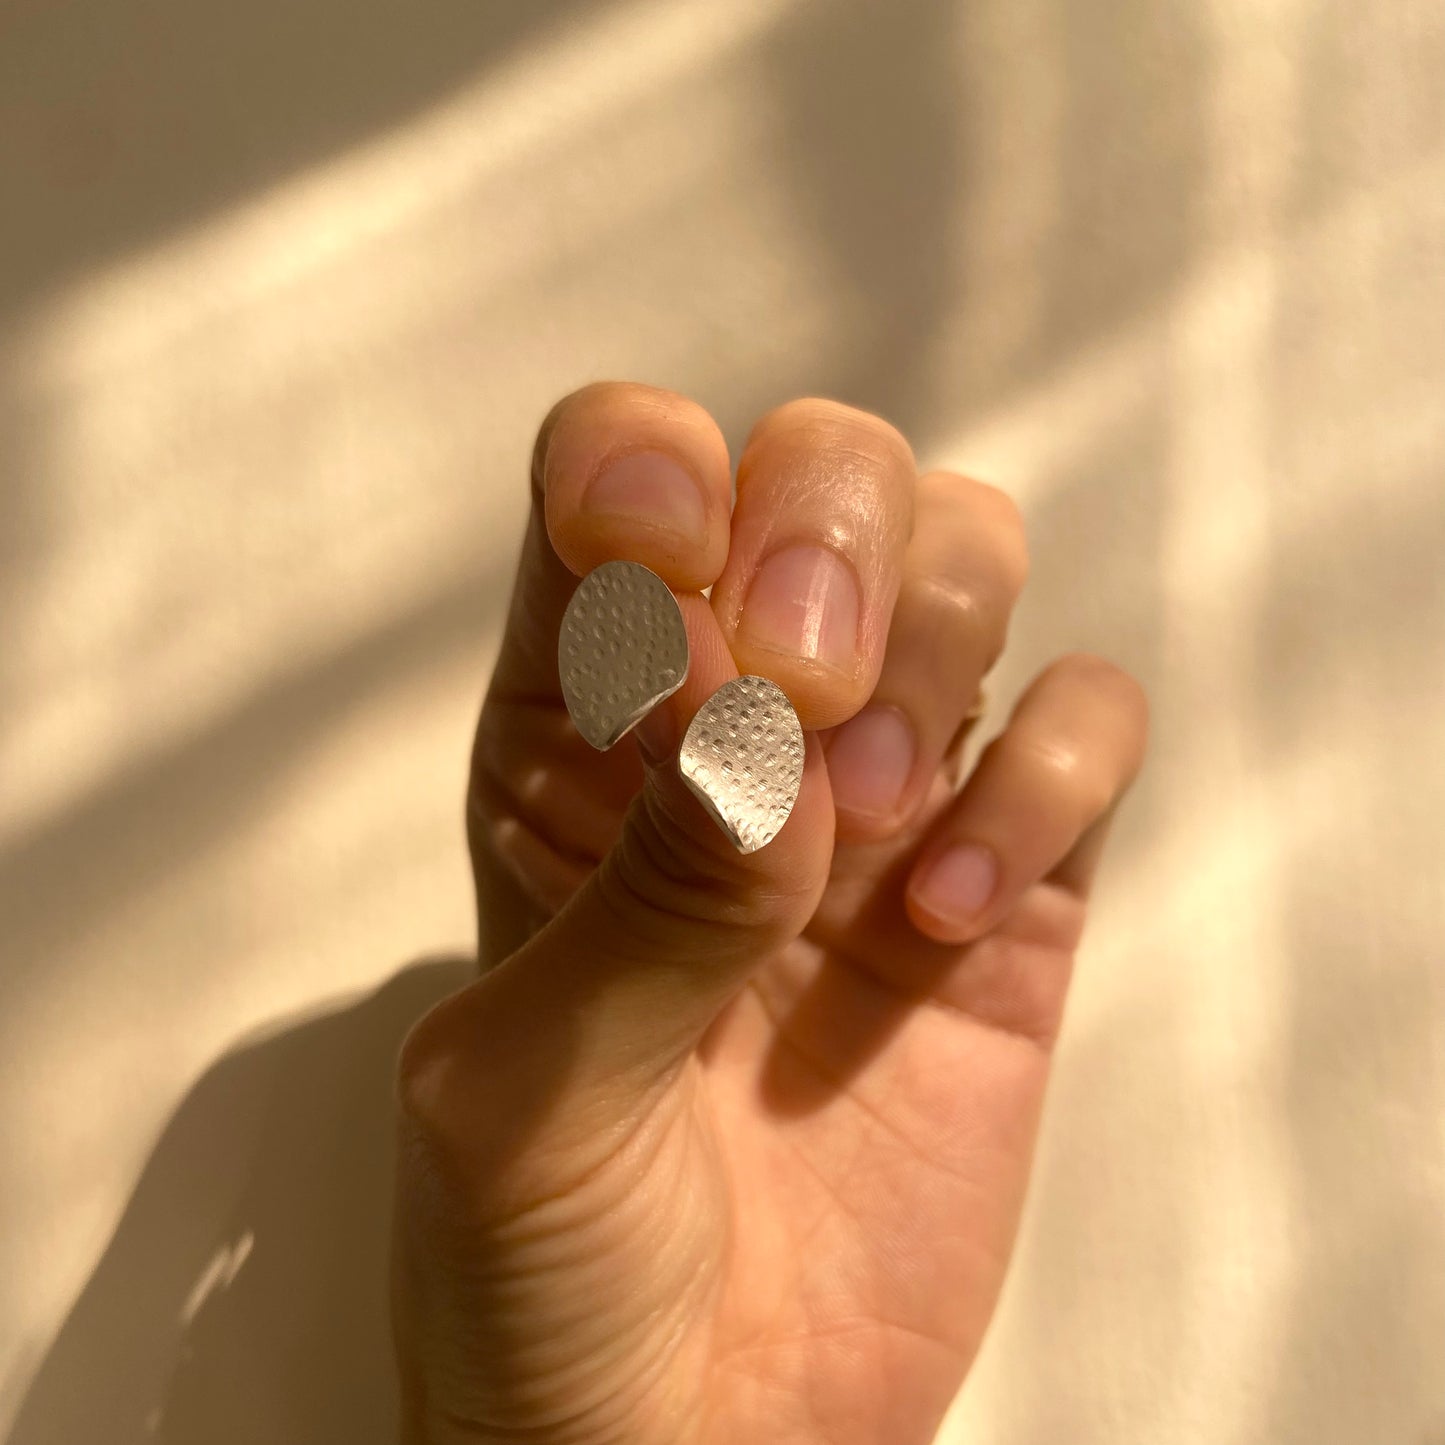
400 592 834 1181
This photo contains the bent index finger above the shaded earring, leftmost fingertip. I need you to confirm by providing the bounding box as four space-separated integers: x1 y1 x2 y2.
493 381 731 701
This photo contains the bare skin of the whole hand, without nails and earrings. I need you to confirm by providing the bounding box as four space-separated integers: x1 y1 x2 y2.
393 383 1146 1445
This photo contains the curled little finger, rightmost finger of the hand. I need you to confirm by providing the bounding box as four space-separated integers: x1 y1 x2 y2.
906 655 1147 944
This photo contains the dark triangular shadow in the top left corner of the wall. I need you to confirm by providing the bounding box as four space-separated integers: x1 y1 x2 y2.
0 0 605 325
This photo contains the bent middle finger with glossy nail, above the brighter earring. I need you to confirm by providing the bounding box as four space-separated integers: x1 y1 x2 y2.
712 399 915 728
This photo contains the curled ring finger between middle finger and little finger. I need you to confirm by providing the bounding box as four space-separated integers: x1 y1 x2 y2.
825 471 1027 841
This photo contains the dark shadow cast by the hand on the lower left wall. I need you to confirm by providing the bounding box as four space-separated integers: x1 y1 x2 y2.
9 959 475 1445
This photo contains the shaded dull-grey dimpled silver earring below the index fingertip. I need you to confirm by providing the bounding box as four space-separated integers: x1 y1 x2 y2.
556 562 688 749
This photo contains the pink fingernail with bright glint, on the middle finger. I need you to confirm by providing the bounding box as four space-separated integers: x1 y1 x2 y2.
741 546 858 672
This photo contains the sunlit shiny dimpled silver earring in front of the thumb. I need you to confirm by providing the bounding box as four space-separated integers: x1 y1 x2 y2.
678 678 803 853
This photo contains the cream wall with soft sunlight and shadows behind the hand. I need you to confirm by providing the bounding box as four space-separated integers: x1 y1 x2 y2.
0 0 1445 1445
